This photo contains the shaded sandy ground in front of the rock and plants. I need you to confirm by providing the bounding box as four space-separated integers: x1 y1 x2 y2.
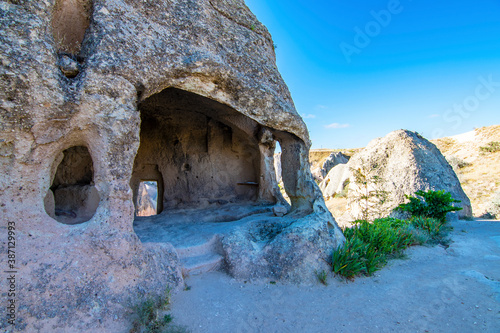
172 220 500 332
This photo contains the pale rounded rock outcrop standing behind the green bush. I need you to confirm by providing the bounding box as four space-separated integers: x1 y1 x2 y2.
334 130 472 221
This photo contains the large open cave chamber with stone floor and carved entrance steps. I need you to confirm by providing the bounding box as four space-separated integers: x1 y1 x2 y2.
130 88 296 274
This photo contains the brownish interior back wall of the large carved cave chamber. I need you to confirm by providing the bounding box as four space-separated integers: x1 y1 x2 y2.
131 88 261 211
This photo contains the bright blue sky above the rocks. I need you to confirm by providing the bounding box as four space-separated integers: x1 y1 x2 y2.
246 0 500 148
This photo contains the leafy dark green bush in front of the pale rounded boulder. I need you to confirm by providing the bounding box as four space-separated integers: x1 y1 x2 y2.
396 190 462 223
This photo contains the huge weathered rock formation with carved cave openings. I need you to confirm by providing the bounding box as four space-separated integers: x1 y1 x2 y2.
0 0 343 332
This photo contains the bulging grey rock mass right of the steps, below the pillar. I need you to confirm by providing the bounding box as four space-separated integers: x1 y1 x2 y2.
222 200 344 283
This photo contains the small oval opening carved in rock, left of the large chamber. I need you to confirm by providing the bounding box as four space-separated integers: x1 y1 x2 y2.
45 146 100 224
